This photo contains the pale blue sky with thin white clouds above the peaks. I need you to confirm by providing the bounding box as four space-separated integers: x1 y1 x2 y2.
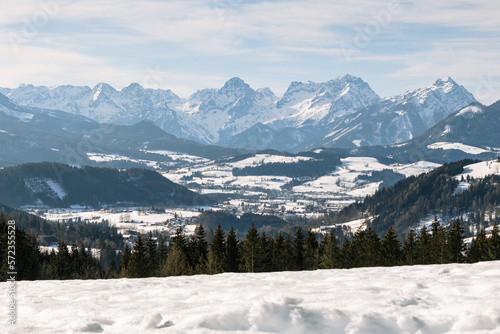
0 0 500 104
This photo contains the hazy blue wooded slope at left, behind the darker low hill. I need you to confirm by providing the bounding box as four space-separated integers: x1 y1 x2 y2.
0 94 248 168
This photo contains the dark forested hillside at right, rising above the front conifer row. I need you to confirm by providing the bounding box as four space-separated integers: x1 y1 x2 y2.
333 160 500 233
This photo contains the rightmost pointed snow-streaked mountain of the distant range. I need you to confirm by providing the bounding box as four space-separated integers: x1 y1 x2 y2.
312 77 476 148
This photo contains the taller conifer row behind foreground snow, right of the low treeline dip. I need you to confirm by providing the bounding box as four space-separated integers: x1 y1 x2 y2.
115 220 500 278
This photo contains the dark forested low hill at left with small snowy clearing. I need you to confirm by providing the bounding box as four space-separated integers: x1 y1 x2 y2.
0 163 209 207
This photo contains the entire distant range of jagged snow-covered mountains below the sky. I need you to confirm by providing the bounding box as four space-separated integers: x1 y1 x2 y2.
0 75 477 150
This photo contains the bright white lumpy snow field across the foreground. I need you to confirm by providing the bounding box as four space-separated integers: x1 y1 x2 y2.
0 261 500 334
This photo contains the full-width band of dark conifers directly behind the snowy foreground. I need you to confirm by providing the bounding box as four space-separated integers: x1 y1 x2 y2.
0 212 500 281
